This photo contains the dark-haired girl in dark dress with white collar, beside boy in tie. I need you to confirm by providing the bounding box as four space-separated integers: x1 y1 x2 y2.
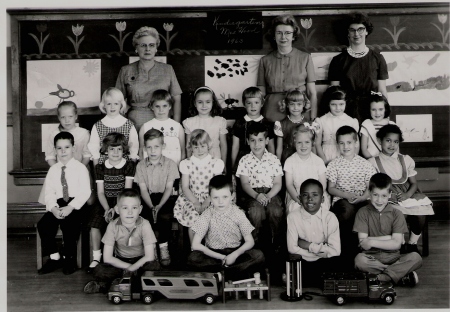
87 132 136 273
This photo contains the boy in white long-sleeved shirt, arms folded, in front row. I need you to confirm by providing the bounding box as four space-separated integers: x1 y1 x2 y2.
287 179 342 286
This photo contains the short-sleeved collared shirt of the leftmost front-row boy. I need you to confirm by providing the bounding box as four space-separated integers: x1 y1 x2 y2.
102 217 156 258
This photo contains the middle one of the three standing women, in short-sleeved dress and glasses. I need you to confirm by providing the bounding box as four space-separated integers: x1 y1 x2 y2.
257 15 317 122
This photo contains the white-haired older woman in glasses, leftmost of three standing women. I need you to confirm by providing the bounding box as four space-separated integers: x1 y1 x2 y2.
116 27 182 132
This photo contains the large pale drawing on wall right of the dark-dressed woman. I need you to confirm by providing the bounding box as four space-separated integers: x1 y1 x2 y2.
382 51 450 106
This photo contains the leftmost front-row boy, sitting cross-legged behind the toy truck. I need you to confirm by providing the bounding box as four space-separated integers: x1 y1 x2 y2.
84 189 160 294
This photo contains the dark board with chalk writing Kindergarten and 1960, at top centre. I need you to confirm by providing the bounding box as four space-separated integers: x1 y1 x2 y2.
205 11 263 50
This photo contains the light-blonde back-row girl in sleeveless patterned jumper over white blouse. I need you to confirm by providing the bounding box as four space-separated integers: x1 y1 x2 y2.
88 88 139 166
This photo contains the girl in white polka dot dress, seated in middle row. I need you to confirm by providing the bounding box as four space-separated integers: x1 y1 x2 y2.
173 129 225 242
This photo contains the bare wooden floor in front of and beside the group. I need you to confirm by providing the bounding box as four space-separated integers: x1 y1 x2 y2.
7 221 450 312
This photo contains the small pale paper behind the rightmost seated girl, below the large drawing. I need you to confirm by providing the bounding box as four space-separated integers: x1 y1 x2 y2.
395 114 433 142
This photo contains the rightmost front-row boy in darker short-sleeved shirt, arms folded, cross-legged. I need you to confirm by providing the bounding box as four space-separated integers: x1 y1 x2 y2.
353 173 422 286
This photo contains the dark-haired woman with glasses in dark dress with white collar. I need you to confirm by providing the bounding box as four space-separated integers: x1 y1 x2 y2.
327 12 389 122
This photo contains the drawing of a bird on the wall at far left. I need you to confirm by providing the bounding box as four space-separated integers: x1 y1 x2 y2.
27 59 101 116
